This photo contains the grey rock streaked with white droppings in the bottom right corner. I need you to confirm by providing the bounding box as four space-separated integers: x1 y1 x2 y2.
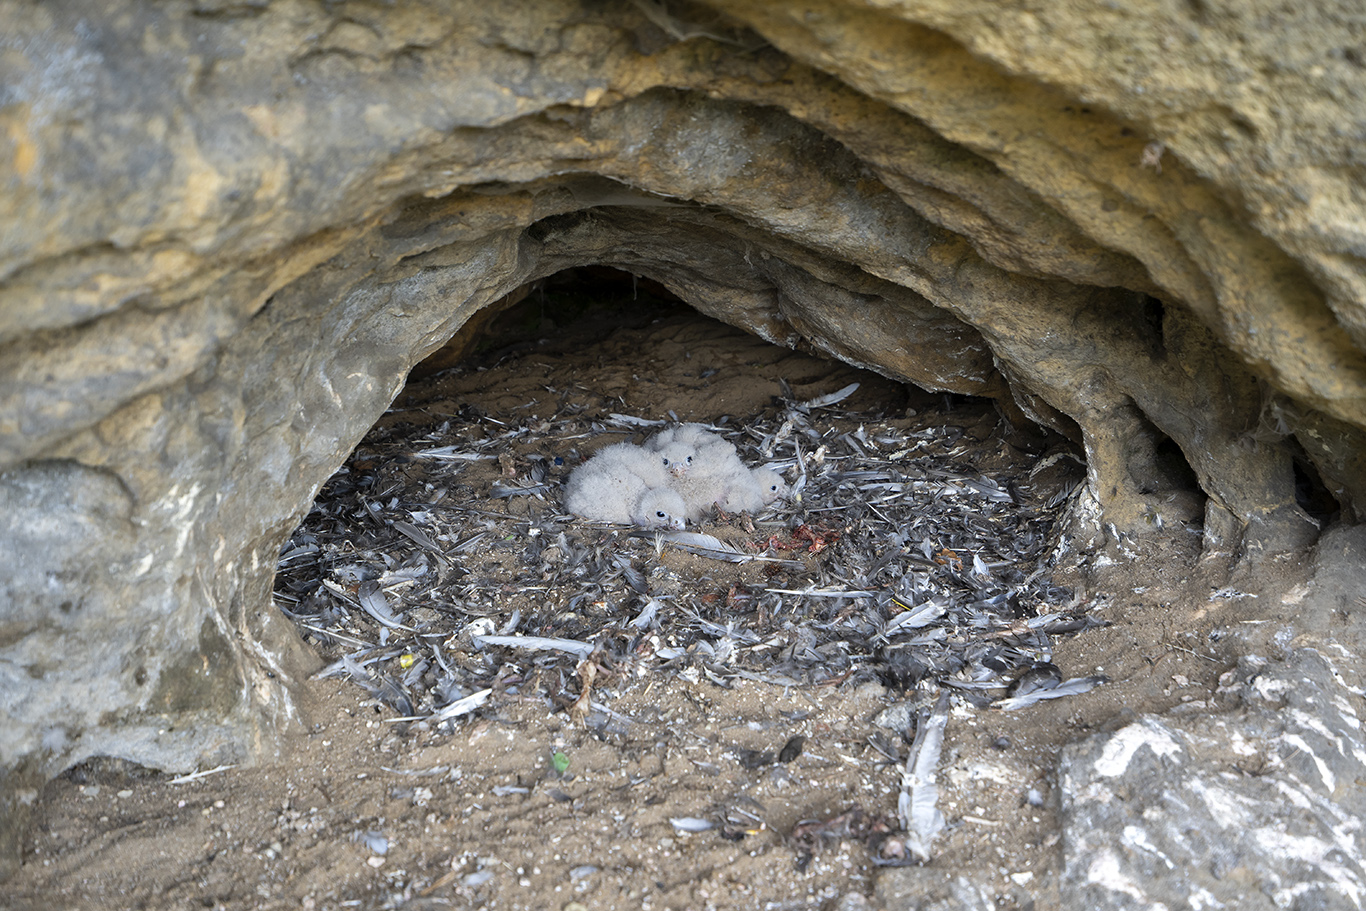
1059 529 1366 911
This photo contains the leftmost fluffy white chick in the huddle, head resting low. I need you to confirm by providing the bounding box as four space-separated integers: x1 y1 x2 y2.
564 443 693 529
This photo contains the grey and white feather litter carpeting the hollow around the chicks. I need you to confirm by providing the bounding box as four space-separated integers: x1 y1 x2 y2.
276 337 1104 859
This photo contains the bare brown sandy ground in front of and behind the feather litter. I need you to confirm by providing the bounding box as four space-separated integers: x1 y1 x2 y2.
10 278 1302 911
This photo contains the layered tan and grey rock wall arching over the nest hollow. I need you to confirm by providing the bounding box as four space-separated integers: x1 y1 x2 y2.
0 0 1366 885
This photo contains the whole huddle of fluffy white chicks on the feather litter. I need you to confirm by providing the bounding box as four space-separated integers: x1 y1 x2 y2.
564 423 787 529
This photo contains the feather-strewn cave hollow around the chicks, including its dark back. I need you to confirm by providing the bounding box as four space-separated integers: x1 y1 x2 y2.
276 266 1103 736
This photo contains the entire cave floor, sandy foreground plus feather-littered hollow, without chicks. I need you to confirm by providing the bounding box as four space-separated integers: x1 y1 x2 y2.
7 285 1305 911
